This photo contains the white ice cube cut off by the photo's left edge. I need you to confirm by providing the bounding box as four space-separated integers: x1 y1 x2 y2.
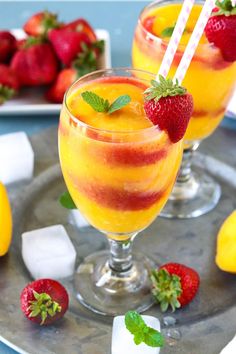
0 132 34 184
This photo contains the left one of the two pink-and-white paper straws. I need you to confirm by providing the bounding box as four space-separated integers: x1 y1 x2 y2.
156 0 195 81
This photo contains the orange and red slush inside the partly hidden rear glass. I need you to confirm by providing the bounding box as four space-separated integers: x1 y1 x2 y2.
132 1 236 141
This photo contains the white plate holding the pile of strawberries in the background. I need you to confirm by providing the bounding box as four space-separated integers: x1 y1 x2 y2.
0 29 111 116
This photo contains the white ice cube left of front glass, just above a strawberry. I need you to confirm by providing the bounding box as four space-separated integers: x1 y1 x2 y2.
22 225 76 279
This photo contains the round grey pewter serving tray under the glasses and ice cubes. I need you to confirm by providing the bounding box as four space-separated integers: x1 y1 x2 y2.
0 128 236 354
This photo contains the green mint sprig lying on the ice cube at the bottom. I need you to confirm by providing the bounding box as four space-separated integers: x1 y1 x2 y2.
125 311 165 347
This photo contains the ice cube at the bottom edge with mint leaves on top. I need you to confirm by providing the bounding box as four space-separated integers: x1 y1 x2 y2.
111 315 160 354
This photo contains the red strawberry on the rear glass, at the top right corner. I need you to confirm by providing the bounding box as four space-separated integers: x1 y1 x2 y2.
205 0 236 62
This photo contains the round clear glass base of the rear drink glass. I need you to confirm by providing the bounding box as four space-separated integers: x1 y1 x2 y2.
160 172 221 219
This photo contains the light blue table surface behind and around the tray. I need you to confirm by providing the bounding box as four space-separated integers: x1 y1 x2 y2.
0 0 235 354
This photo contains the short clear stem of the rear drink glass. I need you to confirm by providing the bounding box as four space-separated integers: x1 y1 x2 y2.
177 141 199 183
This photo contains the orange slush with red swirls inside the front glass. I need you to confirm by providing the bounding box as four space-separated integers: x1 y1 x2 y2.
59 76 182 240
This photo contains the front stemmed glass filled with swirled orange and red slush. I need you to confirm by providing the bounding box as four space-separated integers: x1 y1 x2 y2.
59 69 183 315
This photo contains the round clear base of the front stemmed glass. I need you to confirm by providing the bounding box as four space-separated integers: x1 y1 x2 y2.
75 251 155 316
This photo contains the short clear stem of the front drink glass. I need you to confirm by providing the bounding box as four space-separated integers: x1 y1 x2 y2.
109 236 134 273
